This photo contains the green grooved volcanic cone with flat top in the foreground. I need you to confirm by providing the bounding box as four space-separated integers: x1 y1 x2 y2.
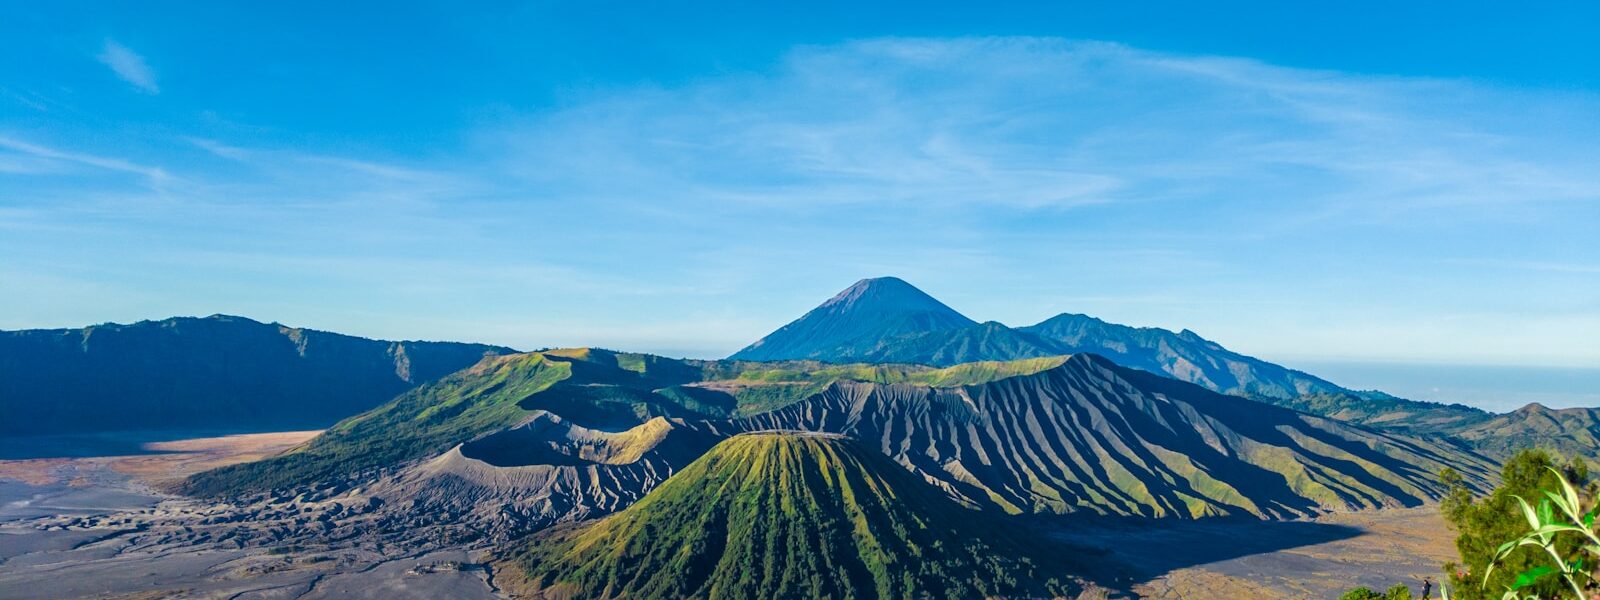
514 434 1069 598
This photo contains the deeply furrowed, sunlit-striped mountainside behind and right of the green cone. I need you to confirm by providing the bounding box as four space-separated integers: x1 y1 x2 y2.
720 355 1493 518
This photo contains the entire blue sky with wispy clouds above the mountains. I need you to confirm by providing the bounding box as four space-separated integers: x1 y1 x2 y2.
0 2 1600 395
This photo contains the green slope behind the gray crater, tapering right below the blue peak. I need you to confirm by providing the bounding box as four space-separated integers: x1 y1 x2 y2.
181 349 1066 496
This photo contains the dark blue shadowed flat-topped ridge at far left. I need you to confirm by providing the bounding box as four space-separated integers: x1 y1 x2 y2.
0 315 512 435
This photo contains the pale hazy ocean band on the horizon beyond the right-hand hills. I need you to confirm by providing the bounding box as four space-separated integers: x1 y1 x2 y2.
1290 360 1600 413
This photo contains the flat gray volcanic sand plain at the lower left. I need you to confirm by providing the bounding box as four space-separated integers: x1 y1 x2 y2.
0 432 496 600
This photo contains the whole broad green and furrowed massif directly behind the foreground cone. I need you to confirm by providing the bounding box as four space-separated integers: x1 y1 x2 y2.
184 349 1490 523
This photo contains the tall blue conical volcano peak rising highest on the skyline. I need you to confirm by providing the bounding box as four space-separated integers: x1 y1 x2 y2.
730 277 978 362
